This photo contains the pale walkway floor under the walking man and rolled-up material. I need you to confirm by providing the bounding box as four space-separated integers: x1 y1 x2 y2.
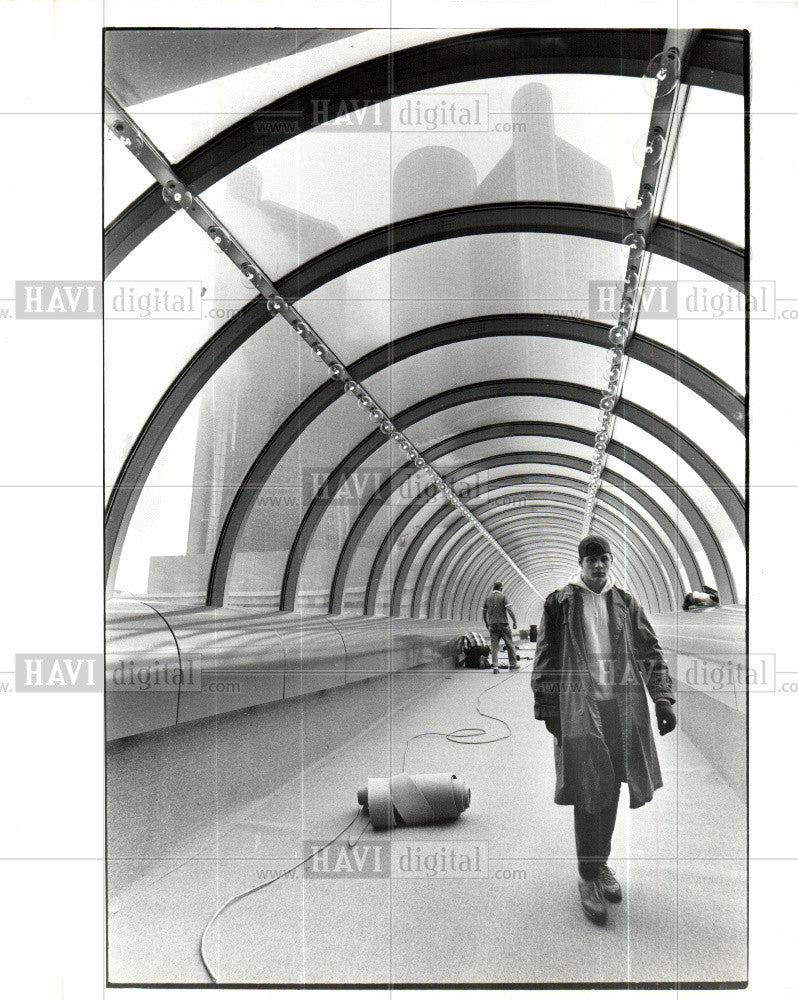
109 650 747 985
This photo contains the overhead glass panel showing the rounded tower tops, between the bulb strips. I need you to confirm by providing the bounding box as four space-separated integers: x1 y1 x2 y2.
203 74 651 287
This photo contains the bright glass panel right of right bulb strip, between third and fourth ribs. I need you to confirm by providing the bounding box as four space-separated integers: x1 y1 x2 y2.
622 360 745 490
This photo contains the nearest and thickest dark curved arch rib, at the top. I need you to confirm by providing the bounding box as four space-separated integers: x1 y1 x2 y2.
105 29 745 277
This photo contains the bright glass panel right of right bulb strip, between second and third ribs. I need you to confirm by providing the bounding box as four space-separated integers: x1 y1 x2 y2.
637 257 745 393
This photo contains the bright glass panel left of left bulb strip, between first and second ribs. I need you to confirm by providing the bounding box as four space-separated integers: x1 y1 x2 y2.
104 212 254 484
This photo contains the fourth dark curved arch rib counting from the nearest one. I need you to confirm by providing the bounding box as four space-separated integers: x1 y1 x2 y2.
282 379 745 611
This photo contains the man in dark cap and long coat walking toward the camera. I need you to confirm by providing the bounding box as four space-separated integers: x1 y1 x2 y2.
532 535 676 923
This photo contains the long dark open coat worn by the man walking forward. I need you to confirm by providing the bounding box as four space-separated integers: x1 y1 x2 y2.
532 583 675 812
